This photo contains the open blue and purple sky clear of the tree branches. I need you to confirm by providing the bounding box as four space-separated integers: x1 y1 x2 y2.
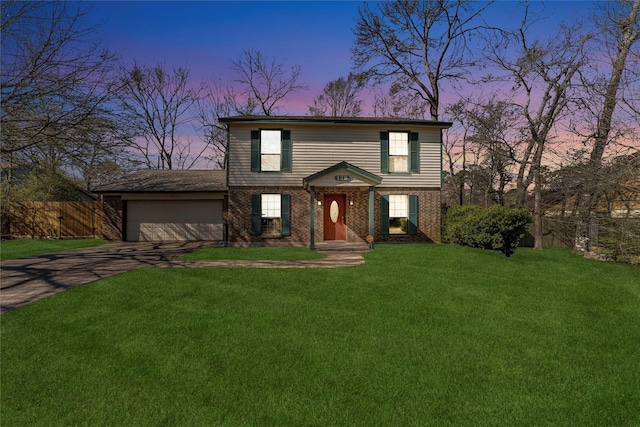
88 0 595 114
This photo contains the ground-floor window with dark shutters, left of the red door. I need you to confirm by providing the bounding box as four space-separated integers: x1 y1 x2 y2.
251 194 291 237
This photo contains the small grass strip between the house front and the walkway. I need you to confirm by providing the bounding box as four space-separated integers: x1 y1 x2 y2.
179 246 325 261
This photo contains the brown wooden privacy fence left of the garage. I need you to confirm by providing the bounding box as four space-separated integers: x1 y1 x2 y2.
9 202 102 239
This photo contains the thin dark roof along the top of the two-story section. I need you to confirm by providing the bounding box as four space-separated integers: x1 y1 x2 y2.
219 115 453 129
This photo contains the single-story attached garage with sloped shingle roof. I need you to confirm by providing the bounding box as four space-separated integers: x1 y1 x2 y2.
96 170 227 242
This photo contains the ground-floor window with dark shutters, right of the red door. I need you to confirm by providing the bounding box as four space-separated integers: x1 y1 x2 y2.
380 194 418 234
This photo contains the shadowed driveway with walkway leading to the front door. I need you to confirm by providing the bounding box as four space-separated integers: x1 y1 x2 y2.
0 242 364 313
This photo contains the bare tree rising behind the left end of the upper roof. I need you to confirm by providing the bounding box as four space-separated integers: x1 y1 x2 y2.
229 49 307 116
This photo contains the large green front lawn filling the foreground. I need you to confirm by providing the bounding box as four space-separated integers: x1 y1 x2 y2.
1 245 640 426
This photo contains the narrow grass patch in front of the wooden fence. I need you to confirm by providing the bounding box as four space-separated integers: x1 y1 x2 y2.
0 239 109 261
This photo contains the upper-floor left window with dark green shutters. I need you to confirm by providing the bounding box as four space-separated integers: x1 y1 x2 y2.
251 129 291 172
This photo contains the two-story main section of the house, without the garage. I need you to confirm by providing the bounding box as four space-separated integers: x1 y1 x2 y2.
220 116 451 248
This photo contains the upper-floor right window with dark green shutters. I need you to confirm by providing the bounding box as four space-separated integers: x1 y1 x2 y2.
380 131 420 173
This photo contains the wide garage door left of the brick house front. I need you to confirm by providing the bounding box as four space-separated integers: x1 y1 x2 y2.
126 200 223 242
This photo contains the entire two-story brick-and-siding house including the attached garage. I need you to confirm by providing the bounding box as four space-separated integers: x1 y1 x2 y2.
97 116 451 247
